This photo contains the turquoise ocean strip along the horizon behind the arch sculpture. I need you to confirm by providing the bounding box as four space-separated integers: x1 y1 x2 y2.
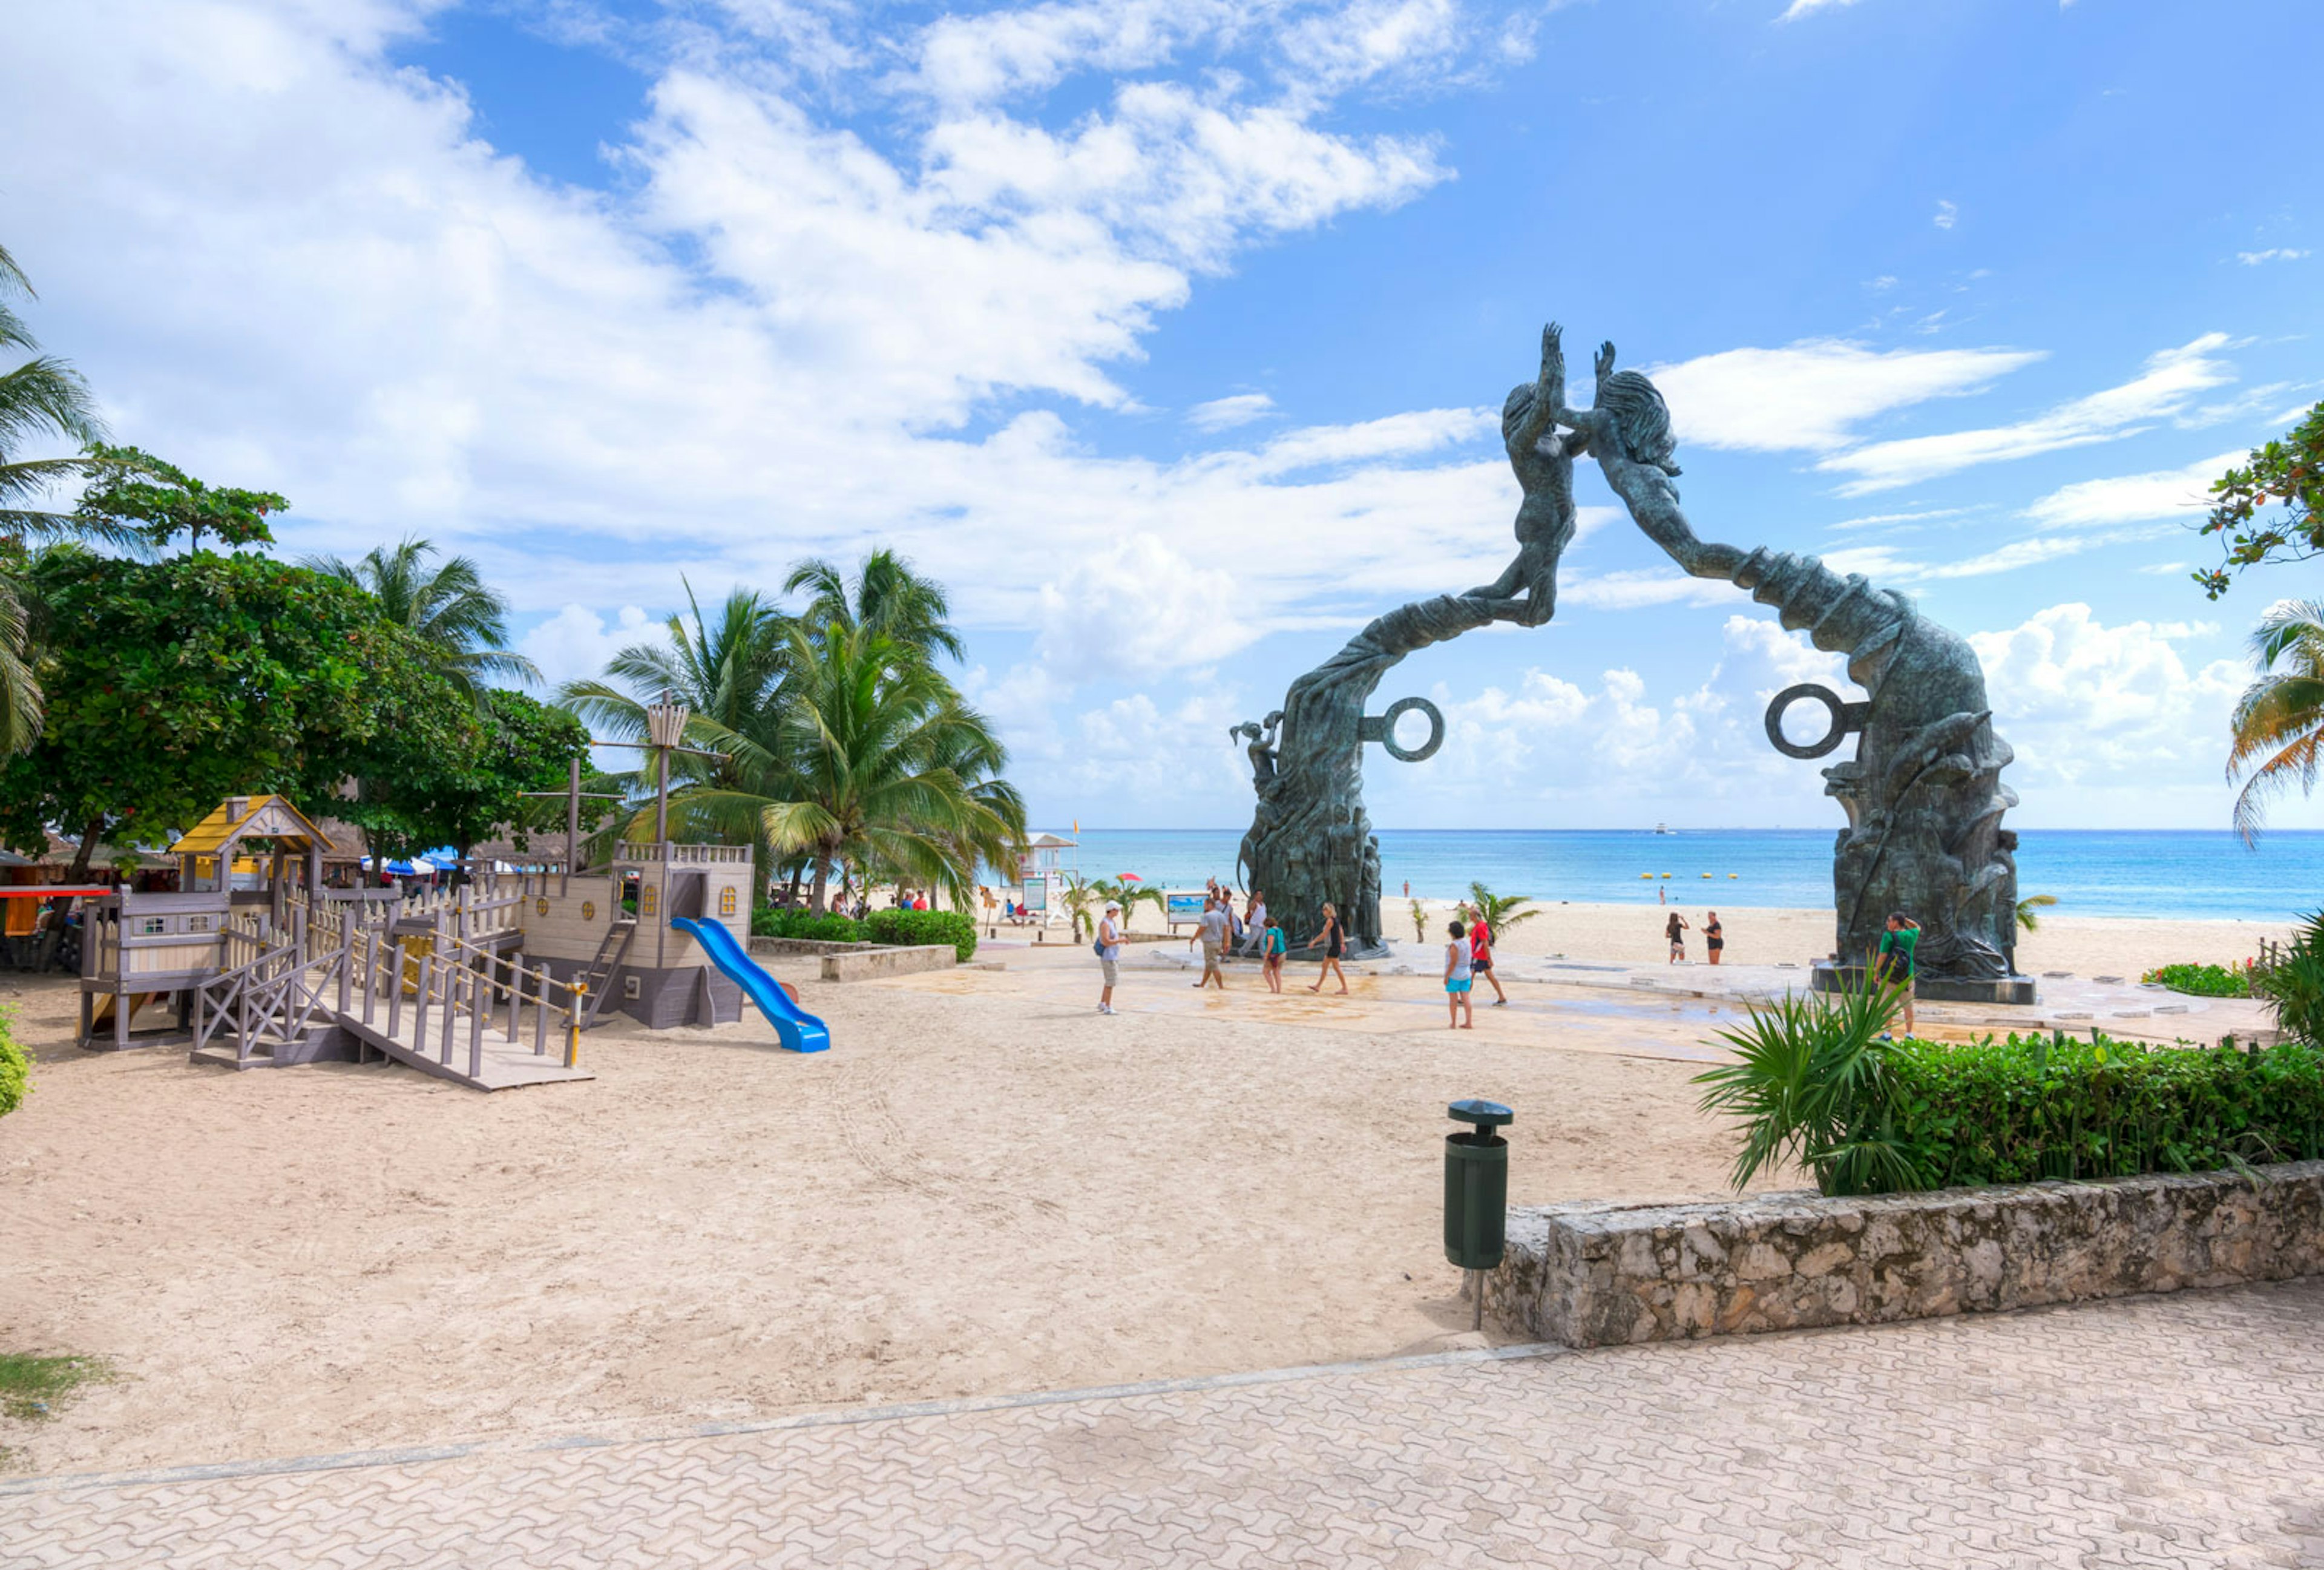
1065 829 2324 922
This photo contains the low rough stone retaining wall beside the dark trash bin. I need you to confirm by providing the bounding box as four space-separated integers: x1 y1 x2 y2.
1485 1161 2324 1347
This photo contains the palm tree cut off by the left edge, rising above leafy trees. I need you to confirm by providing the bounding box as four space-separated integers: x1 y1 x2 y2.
0 249 142 757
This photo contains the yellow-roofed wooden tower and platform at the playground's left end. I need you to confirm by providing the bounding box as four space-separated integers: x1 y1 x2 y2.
81 794 330 1052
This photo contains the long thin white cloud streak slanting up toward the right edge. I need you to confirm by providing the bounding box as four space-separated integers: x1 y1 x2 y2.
1815 332 2236 497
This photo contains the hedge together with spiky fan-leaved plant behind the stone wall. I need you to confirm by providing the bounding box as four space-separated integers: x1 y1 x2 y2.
1696 994 2324 1194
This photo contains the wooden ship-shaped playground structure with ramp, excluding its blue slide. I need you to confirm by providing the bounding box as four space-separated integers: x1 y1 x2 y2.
79 794 753 1089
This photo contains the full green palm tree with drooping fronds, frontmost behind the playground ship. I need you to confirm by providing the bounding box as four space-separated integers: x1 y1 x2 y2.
683 622 1023 913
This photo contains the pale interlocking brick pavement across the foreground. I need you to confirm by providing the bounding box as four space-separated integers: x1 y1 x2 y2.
0 1282 2324 1570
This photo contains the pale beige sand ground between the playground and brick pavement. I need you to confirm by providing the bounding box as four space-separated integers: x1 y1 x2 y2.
0 906 2261 1473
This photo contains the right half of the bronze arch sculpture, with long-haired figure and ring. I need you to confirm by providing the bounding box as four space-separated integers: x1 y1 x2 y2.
1557 344 2034 1003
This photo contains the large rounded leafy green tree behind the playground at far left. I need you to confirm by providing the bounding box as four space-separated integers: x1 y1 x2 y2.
0 546 476 878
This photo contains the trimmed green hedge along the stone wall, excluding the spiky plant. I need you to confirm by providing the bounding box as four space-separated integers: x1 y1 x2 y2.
1857 1034 2324 1189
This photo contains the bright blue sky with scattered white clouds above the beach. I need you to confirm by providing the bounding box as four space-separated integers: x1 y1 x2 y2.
0 0 2324 827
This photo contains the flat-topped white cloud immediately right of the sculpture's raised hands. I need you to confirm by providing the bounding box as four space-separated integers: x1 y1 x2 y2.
1650 339 2043 453
